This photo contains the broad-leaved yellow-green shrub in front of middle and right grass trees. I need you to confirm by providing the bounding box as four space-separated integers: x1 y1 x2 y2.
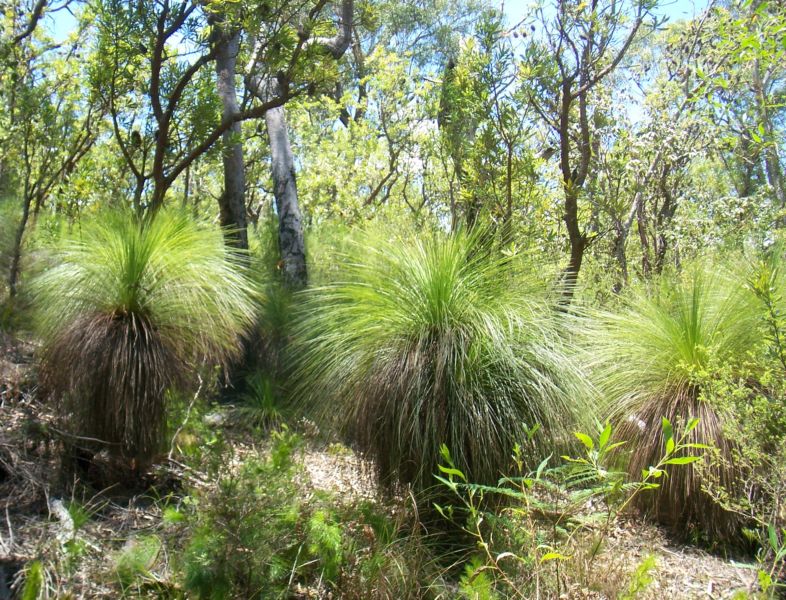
437 419 707 598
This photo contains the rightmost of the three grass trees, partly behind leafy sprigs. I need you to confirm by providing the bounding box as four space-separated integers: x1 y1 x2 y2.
589 265 760 539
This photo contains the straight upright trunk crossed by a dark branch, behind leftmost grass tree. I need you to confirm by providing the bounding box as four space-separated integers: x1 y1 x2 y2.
214 26 248 250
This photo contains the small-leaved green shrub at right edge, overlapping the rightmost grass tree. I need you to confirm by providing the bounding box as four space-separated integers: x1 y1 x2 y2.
703 245 786 580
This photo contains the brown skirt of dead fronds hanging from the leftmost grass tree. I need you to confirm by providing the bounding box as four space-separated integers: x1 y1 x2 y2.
41 313 186 464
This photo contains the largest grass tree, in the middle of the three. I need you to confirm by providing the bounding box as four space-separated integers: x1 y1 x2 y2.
296 227 589 491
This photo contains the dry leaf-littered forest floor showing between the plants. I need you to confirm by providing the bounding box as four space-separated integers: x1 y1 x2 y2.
0 332 756 600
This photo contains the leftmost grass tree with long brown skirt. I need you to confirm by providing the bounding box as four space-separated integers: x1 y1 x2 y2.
34 213 255 465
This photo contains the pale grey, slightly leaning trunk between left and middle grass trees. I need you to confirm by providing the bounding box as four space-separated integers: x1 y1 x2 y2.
265 107 308 289
